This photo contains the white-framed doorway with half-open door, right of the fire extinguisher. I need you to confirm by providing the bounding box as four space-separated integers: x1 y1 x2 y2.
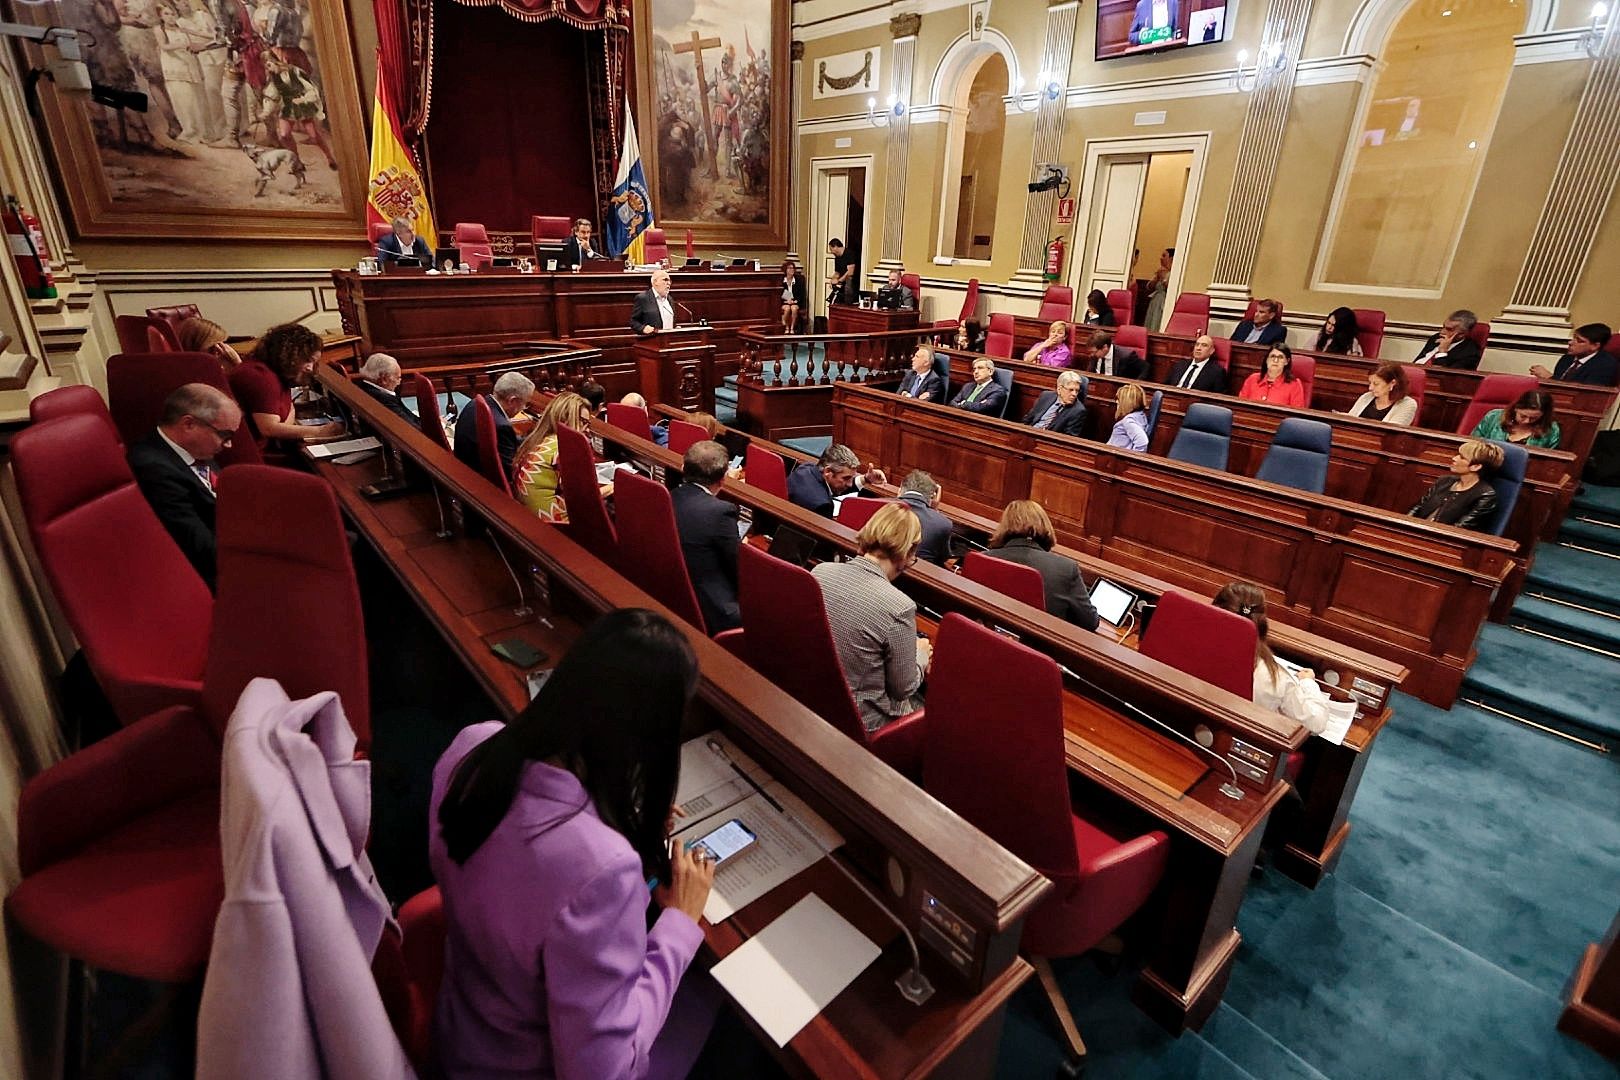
1069 134 1209 329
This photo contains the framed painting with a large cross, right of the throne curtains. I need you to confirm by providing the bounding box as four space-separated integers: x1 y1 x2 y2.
633 0 792 248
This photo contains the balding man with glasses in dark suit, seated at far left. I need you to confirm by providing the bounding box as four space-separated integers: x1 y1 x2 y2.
130 382 241 589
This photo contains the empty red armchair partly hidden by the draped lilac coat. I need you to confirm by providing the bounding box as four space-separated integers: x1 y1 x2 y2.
6 469 369 983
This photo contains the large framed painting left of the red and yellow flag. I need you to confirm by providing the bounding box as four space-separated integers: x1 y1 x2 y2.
18 0 369 240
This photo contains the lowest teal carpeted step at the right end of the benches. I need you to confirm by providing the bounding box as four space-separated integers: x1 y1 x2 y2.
1461 623 1620 743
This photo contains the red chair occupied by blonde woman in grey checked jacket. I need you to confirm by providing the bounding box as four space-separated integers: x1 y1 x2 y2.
737 544 923 777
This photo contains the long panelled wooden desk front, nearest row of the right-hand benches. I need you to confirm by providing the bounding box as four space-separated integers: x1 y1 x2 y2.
833 384 1515 706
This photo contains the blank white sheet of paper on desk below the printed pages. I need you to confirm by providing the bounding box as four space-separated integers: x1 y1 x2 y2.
713 892 883 1046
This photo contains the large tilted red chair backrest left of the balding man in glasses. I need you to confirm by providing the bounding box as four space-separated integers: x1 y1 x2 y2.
11 415 214 724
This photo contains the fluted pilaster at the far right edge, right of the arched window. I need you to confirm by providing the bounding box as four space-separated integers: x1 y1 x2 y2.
1492 26 1620 340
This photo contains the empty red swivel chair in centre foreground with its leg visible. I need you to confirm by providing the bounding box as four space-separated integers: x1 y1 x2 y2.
923 614 1170 1059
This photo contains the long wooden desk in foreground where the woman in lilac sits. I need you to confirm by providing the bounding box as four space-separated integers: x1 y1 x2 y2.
318 366 1050 1077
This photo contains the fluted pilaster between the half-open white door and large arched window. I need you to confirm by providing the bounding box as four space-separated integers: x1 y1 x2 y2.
1210 0 1311 308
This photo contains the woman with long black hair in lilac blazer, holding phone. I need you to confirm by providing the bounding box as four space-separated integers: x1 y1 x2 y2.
429 609 714 1078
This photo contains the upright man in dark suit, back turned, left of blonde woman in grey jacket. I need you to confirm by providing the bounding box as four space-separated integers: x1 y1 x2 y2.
672 439 742 633
